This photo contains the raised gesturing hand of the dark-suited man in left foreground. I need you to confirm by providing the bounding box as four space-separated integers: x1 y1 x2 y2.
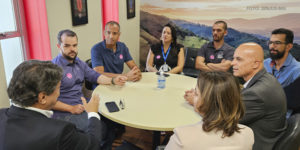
81 94 100 113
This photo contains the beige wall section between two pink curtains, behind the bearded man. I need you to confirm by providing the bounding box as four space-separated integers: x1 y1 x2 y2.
46 0 102 61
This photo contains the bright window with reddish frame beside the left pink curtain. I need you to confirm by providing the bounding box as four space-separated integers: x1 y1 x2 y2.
0 0 26 85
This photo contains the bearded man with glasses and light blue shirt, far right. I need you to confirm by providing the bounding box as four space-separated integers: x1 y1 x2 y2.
264 28 300 87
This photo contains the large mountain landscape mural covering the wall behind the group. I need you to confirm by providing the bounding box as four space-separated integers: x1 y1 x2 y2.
140 0 300 69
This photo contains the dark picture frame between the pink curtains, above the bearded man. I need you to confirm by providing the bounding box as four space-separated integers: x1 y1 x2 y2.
70 0 88 26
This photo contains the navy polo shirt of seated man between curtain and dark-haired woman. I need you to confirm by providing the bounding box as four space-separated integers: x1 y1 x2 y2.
91 40 132 74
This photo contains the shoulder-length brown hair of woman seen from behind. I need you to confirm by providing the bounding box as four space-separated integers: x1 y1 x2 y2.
194 72 244 137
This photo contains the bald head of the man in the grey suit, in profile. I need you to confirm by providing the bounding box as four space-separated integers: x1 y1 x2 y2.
232 43 264 81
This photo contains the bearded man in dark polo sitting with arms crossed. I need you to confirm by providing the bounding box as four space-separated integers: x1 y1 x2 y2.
195 21 234 71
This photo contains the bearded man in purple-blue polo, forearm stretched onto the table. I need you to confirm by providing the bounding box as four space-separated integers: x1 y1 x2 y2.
49 30 127 131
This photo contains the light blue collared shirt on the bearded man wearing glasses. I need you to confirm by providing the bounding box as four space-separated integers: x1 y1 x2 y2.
264 53 300 88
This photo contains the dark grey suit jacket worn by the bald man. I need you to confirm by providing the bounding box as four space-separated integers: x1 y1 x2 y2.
240 69 287 150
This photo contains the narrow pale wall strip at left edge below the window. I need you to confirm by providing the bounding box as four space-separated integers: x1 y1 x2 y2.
0 45 9 108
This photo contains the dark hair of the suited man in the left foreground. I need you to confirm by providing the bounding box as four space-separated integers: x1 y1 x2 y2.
7 60 62 107
